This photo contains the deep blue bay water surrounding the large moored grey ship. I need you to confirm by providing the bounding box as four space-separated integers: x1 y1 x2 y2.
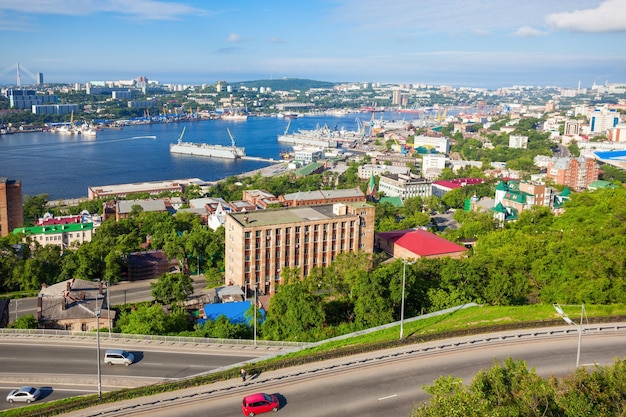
0 113 392 200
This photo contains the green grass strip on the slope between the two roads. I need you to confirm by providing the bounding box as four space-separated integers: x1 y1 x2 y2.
0 304 626 416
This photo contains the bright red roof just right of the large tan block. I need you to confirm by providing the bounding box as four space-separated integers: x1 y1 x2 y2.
378 229 467 256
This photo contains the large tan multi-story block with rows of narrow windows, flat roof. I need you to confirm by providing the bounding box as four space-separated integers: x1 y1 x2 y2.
225 202 375 295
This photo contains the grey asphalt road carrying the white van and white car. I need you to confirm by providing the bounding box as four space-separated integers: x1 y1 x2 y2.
0 337 262 411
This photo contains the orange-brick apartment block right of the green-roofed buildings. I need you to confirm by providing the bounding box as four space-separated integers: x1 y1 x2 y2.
546 157 600 191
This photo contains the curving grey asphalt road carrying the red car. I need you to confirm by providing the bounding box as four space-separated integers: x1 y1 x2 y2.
112 334 626 417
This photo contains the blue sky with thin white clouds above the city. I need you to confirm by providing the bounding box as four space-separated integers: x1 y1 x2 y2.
0 0 626 88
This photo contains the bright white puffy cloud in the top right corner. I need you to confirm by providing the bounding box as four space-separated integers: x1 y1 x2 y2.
546 0 626 32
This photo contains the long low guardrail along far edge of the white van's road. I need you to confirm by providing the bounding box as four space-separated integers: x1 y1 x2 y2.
0 329 310 348
